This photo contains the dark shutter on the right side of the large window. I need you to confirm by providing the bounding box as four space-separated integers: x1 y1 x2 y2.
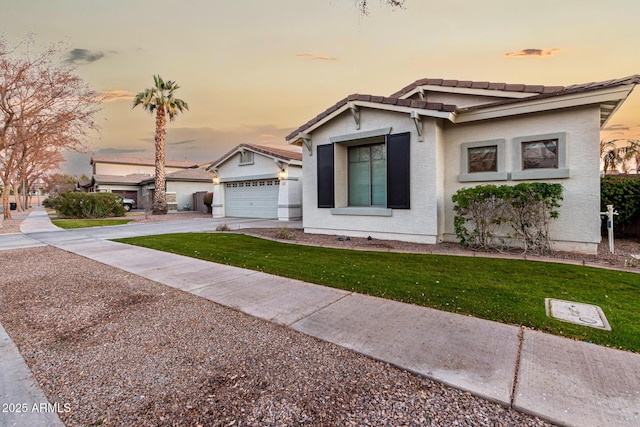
387 132 411 209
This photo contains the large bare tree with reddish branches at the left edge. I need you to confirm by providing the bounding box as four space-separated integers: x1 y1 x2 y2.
0 35 100 219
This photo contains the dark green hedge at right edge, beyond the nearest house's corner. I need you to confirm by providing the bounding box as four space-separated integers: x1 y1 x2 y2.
600 175 640 236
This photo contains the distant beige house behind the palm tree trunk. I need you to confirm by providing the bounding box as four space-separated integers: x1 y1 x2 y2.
78 156 204 210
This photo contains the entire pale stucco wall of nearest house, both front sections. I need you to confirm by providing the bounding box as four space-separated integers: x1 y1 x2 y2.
303 106 600 253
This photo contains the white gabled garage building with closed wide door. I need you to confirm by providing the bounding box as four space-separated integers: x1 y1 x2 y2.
208 144 302 221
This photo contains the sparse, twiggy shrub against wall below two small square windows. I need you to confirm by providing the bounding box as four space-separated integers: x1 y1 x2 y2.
452 182 562 253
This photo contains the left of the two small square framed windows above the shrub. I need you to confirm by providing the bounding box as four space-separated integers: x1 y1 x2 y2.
458 139 508 182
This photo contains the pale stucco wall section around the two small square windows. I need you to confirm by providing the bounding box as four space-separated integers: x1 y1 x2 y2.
444 106 600 253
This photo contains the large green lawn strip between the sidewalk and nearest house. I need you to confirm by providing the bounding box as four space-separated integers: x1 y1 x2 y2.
117 233 640 352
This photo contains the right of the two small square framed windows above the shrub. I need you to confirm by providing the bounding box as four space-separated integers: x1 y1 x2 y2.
511 132 570 181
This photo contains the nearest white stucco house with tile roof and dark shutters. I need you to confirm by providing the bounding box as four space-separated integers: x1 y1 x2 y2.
286 76 640 253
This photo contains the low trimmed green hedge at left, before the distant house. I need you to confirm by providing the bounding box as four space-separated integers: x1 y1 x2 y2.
52 193 126 218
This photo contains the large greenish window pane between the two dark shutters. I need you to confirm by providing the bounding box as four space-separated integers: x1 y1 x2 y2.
348 143 387 206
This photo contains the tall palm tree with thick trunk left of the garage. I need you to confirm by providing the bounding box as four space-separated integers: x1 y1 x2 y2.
132 76 189 215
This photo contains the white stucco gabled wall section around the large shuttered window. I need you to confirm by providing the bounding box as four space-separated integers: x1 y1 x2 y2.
302 108 438 243
